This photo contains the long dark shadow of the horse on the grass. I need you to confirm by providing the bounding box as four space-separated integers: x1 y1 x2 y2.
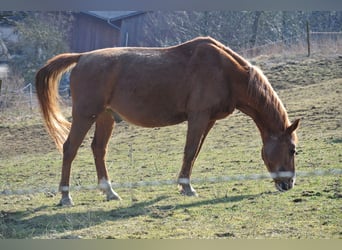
0 195 258 238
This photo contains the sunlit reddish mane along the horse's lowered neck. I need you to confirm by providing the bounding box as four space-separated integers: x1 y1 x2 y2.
203 37 290 130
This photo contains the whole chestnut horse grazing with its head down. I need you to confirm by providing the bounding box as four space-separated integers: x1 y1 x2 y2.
36 37 299 205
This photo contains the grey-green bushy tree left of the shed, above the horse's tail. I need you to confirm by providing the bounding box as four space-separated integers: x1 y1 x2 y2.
9 12 72 83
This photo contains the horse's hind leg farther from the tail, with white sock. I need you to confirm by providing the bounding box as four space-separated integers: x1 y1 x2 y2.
91 111 121 200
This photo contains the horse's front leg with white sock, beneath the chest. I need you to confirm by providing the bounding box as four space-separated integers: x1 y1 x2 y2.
178 117 215 196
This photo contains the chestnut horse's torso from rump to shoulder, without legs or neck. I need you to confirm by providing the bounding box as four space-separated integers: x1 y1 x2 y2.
71 38 234 127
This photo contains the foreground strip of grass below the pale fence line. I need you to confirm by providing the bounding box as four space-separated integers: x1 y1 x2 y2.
0 177 341 239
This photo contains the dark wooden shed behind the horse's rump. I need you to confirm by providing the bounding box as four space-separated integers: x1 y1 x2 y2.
71 11 146 52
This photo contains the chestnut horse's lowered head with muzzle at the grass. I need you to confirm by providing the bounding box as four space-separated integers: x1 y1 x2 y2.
261 119 299 191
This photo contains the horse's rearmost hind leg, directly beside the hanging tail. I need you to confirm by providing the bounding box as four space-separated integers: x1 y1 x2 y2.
59 117 93 206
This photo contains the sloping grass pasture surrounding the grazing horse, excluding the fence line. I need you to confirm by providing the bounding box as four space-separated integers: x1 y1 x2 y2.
0 55 342 239
